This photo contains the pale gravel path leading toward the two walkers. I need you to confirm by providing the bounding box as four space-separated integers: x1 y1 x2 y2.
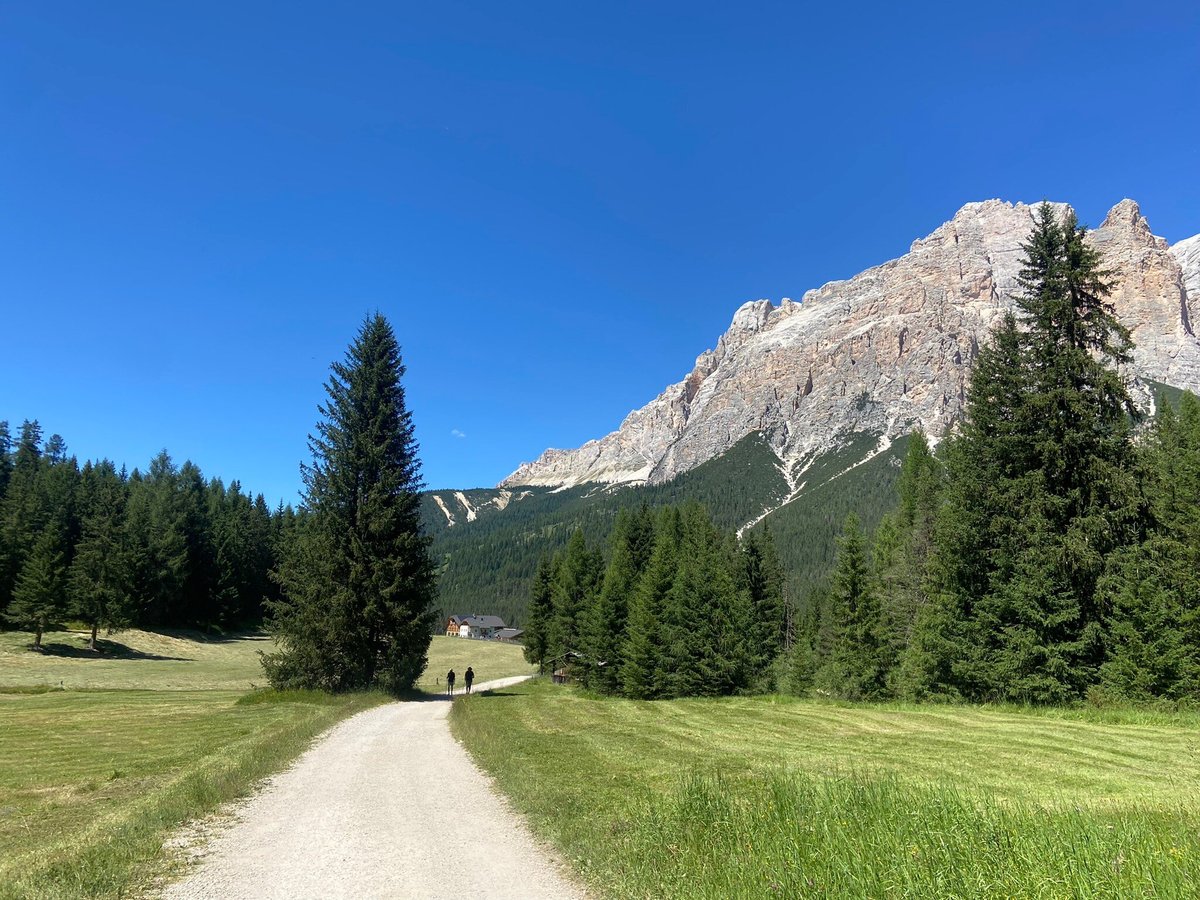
164 678 583 900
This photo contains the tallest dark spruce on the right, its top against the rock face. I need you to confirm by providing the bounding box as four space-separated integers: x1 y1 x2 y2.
905 204 1140 702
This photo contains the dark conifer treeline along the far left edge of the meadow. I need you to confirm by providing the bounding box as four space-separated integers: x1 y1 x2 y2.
0 421 295 648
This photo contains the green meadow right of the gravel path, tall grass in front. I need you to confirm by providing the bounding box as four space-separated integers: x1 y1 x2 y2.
451 680 1200 898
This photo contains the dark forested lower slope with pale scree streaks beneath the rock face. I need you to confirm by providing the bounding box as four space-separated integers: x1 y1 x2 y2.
422 433 906 622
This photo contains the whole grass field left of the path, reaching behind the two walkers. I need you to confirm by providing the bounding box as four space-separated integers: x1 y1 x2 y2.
0 631 528 900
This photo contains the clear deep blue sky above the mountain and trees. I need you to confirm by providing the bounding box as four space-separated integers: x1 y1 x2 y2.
0 0 1200 503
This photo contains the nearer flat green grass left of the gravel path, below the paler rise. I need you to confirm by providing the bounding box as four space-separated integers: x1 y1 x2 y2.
0 691 384 898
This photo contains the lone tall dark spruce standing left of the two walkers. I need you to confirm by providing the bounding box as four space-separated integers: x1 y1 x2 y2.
264 313 437 692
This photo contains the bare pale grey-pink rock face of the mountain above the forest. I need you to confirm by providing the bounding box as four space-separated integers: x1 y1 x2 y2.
502 200 1200 486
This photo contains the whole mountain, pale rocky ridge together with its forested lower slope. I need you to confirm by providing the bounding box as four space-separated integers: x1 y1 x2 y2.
424 200 1200 622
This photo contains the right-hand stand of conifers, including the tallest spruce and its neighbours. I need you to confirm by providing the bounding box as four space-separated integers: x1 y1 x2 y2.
792 206 1200 703
